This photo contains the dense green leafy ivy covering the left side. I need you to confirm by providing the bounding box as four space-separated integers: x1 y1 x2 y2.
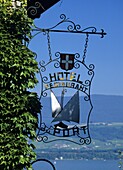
0 0 41 170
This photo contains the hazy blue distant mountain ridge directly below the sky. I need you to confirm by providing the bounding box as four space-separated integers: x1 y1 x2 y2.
42 95 123 123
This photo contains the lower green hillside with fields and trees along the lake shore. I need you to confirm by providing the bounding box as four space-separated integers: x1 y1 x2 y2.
35 123 123 160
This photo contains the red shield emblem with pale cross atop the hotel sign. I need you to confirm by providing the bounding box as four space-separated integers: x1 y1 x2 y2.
60 54 74 71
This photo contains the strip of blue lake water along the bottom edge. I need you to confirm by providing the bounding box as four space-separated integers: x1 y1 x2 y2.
33 160 119 170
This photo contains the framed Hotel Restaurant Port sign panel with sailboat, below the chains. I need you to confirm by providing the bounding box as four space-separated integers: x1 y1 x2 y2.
37 52 94 144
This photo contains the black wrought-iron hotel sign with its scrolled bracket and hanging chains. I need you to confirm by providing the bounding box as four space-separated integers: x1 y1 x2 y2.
30 14 106 145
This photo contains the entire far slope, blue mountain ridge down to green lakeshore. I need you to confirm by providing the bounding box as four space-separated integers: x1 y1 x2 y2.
35 95 123 160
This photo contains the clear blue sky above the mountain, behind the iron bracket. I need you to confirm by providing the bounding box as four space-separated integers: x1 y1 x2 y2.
29 0 123 95
